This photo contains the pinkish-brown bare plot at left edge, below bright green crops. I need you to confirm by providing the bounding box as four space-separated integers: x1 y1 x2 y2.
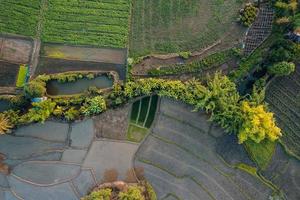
0 36 33 64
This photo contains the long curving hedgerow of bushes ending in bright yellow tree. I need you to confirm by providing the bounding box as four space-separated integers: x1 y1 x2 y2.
0 73 281 143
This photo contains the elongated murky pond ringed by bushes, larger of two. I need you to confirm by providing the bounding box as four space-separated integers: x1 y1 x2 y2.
47 75 113 95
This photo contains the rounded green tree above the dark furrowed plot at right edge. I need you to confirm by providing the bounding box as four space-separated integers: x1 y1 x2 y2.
268 61 296 76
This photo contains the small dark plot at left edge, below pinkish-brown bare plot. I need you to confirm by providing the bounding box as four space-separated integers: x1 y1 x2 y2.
0 61 20 87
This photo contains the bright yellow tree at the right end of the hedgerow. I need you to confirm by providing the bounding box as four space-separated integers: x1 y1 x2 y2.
238 101 281 143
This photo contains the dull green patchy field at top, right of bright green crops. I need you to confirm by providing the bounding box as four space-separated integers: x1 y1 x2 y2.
129 0 244 57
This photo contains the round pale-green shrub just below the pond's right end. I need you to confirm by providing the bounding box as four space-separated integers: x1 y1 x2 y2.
81 96 106 116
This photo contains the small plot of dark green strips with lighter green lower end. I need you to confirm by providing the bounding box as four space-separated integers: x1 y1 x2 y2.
127 95 158 142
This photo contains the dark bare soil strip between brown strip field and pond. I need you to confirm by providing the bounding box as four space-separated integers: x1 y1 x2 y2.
35 57 126 80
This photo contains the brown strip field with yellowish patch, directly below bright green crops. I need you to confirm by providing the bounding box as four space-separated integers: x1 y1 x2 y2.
42 44 127 64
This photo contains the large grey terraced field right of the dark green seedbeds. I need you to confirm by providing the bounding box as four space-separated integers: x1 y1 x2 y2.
135 98 272 200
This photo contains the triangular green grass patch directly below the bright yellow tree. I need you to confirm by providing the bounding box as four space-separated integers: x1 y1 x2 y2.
244 140 276 170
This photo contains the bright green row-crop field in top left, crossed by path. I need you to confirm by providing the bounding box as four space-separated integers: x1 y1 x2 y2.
0 0 131 48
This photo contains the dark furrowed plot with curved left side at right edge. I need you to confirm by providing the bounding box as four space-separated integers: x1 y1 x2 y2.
266 65 300 156
